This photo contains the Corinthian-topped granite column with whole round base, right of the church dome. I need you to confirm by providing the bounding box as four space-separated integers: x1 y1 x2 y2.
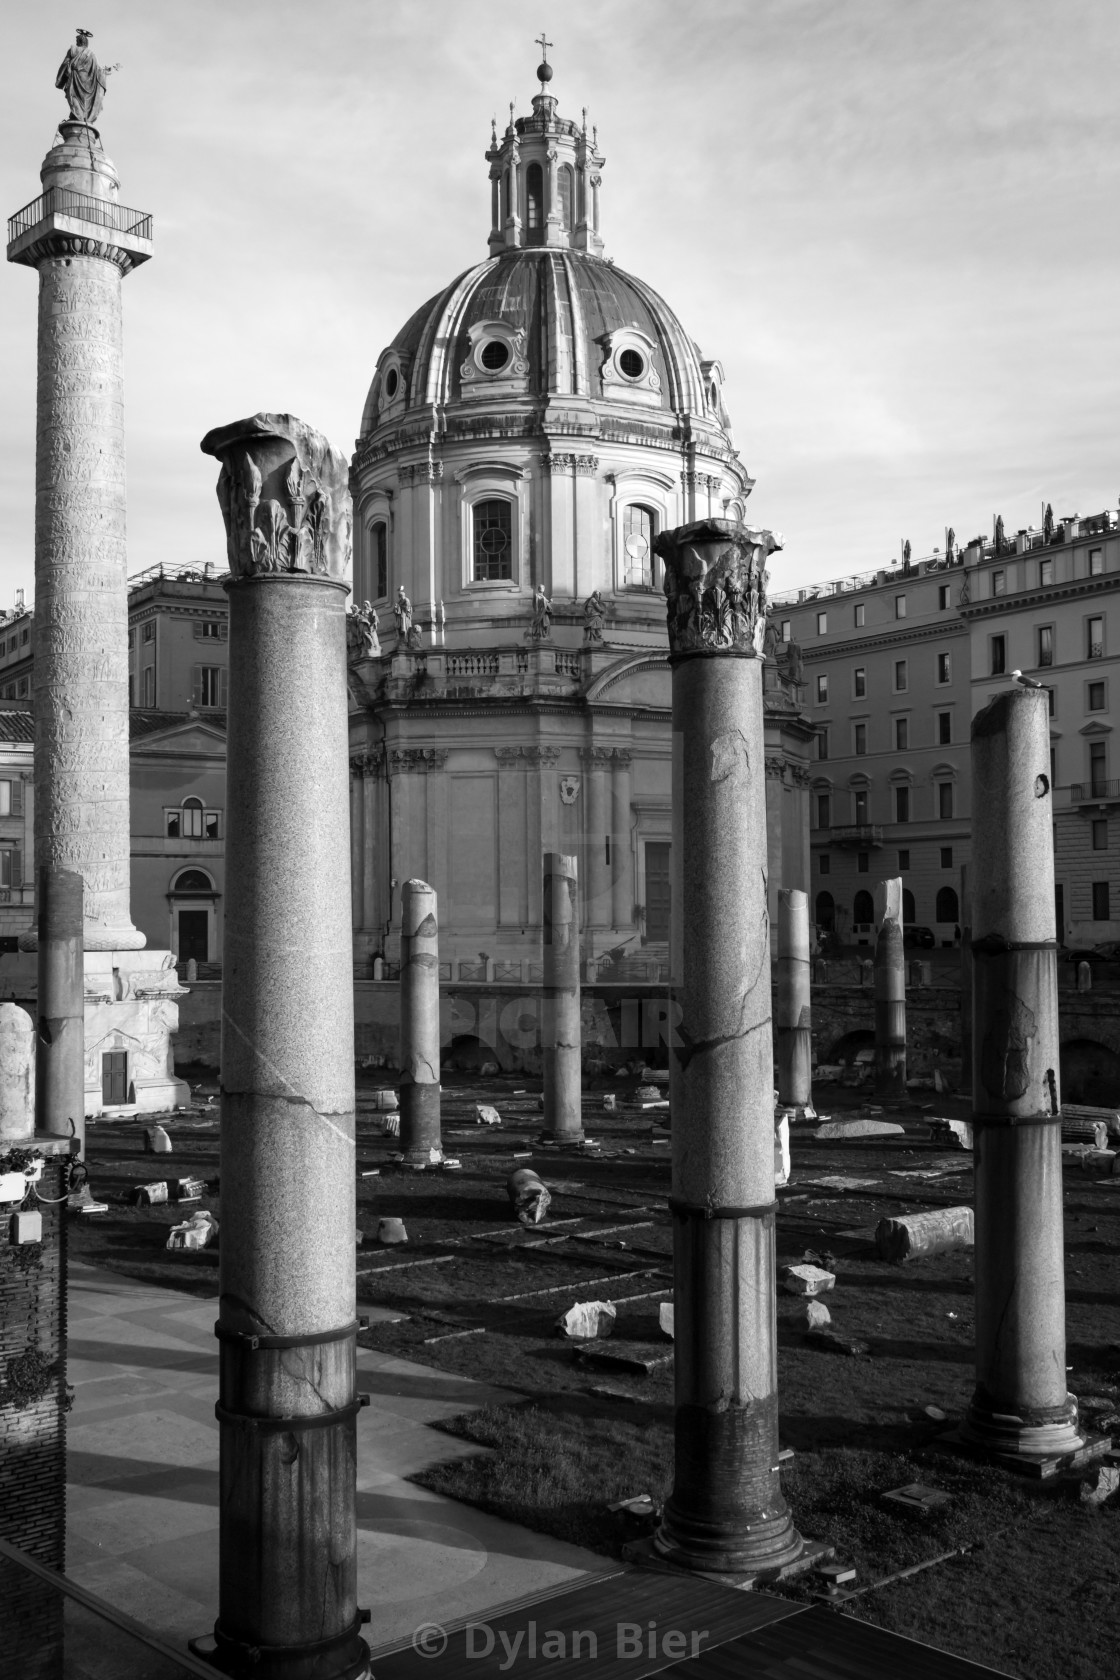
653 519 804 1584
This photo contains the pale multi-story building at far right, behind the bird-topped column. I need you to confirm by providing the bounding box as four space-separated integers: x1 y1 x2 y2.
959 512 1120 946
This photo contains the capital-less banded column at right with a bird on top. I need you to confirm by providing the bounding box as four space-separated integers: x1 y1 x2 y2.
962 687 1085 1460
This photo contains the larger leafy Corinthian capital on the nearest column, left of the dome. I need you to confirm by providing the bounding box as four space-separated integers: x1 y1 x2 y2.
201 413 351 580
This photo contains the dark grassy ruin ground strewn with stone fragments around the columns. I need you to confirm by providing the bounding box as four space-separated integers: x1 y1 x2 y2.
71 1072 1120 1680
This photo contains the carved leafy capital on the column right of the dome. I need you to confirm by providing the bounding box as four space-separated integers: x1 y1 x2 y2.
653 519 782 655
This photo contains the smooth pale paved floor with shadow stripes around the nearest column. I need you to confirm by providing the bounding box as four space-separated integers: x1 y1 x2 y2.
67 1263 610 1646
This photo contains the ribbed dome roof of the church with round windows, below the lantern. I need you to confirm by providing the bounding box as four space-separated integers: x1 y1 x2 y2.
361 249 727 437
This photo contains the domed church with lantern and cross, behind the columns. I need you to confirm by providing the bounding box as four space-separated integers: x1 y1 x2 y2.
349 64 814 983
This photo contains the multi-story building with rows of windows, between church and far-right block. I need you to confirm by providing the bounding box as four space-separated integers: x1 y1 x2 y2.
772 554 971 944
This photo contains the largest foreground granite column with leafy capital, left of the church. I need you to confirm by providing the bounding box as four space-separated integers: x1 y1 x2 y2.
201 413 368 1680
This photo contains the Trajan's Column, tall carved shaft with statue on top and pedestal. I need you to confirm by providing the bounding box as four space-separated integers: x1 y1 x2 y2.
8 30 188 1114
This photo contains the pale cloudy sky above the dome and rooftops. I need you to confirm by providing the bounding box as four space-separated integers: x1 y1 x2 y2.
0 0 1120 606
